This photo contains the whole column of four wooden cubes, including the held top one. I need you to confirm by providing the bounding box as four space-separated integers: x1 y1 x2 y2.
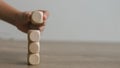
27 11 43 65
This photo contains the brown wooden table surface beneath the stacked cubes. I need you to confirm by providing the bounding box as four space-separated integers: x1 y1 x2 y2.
0 40 120 68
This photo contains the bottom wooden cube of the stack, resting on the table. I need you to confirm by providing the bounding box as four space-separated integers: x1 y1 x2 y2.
28 53 40 65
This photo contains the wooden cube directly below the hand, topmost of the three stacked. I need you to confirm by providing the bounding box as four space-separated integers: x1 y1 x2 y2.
28 30 40 42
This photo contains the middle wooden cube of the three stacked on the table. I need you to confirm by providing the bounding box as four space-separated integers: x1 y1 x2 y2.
28 42 40 53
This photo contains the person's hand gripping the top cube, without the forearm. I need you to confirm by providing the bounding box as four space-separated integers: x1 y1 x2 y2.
15 10 49 33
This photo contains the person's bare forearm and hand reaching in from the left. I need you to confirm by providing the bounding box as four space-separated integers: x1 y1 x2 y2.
0 0 49 33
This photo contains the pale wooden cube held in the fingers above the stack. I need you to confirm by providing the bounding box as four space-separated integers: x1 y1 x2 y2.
31 11 43 25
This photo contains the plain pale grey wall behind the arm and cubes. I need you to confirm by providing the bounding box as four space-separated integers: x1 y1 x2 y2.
0 0 120 42
